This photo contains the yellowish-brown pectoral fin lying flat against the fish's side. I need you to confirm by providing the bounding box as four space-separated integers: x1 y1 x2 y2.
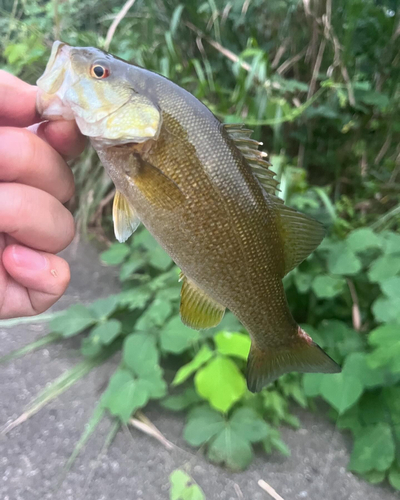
132 155 186 210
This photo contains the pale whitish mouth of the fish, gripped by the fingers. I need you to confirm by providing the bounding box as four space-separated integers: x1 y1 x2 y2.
36 41 77 120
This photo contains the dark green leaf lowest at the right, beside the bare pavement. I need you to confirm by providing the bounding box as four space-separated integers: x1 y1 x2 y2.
349 422 395 474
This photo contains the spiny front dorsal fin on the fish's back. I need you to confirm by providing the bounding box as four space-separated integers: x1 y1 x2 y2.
223 123 279 196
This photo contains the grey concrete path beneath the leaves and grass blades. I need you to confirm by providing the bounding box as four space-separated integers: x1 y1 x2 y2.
0 238 400 500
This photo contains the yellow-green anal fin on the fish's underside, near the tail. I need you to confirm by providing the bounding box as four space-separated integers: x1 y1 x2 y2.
179 276 225 330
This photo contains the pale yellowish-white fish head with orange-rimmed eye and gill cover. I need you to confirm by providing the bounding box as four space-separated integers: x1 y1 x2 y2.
36 41 162 147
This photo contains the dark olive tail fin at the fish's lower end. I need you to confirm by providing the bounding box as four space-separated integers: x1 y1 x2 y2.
247 327 341 392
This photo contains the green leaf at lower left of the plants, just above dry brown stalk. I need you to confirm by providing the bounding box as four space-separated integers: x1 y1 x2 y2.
101 368 149 422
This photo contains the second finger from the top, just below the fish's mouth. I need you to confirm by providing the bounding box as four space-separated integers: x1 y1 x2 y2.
0 127 74 203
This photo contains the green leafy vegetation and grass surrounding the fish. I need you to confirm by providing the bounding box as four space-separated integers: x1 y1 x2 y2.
0 0 400 492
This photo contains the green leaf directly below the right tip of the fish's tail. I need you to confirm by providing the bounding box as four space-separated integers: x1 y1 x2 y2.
320 372 363 414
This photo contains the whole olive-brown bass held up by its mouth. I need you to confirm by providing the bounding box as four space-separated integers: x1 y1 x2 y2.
37 41 340 392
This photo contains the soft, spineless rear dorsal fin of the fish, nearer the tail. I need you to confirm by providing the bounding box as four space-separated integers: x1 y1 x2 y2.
276 204 325 274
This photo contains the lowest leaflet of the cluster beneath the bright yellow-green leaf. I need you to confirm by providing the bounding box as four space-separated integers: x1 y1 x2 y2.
207 424 253 470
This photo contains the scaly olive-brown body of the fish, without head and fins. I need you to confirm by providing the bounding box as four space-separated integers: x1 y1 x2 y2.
99 68 297 347
